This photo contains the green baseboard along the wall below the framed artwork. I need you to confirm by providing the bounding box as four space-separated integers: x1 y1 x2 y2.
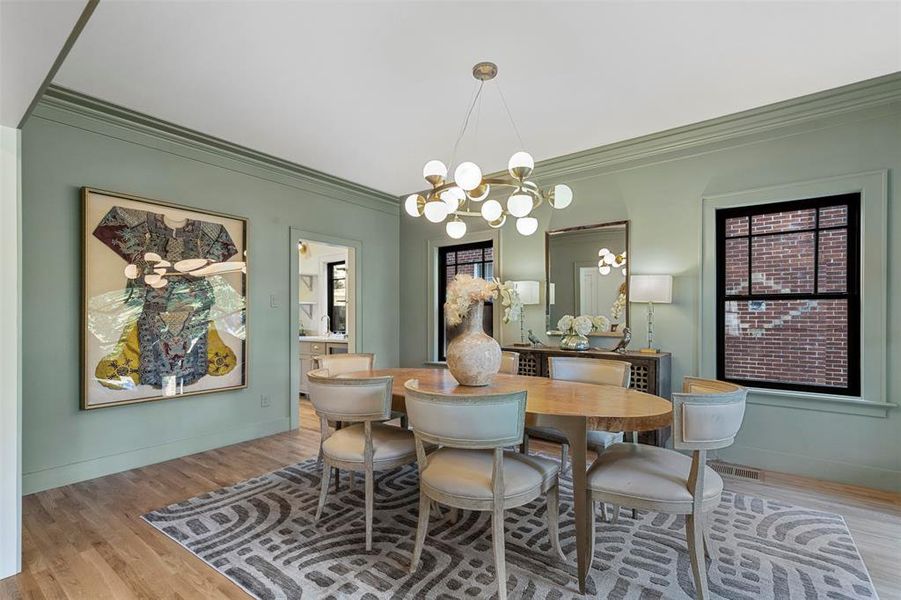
22 417 290 495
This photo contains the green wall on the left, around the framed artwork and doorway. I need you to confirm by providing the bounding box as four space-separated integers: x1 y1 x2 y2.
22 92 399 493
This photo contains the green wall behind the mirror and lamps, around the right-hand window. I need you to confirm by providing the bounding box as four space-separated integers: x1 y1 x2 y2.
400 83 901 490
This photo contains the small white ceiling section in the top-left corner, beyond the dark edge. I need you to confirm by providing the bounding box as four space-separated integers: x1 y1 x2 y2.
0 0 86 127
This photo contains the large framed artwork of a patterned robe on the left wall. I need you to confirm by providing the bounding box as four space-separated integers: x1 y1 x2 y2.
81 188 247 409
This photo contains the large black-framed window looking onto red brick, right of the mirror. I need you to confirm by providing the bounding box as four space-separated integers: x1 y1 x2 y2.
716 194 860 396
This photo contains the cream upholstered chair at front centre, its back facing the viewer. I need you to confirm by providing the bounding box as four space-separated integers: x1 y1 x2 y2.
406 379 564 600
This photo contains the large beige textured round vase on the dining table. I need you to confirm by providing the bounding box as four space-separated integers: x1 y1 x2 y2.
447 302 501 386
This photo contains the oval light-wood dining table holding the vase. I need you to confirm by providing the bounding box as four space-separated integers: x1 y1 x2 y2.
344 368 673 593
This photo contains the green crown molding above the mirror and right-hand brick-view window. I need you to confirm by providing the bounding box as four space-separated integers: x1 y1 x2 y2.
535 72 901 180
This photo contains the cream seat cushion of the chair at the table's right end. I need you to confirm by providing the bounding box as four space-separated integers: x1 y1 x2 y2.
588 443 723 512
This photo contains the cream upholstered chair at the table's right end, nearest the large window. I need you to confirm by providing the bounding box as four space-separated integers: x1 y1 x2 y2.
588 377 748 599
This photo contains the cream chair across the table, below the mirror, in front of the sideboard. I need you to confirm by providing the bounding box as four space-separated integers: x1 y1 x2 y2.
524 356 638 471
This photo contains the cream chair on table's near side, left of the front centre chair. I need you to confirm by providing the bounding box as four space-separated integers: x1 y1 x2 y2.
308 369 416 550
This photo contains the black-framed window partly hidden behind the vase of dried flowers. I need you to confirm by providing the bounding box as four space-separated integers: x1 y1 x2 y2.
438 241 494 360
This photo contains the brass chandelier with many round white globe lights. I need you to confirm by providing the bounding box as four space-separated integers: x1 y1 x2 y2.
404 62 573 239
